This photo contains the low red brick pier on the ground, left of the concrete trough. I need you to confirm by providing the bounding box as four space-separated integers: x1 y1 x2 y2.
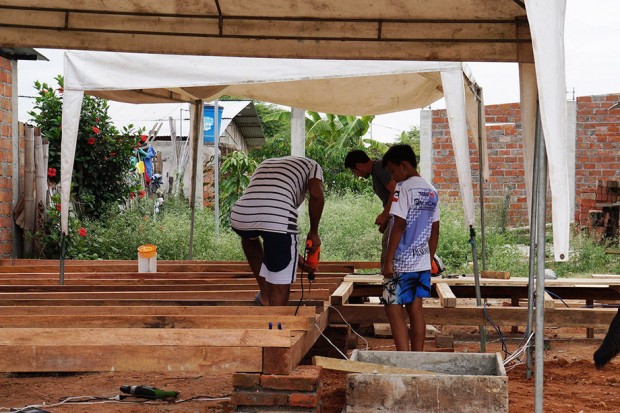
232 366 322 413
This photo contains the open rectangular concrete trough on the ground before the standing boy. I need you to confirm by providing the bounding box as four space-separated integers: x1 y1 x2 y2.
344 350 508 413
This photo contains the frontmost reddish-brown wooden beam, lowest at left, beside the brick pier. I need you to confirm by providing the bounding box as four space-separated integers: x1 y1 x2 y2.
0 344 262 375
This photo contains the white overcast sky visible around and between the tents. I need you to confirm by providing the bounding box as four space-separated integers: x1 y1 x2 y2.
18 0 620 141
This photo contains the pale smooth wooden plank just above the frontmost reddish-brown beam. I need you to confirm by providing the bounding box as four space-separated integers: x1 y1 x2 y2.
0 328 291 349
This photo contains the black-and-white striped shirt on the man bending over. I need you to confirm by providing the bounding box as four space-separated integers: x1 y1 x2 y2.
230 156 323 234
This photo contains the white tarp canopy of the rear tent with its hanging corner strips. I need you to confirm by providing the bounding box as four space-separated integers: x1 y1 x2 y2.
61 51 486 233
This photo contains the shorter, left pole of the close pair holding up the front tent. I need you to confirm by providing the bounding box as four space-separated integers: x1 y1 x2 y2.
525 100 541 379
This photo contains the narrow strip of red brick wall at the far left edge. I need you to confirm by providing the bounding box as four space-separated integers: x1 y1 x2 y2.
0 57 13 258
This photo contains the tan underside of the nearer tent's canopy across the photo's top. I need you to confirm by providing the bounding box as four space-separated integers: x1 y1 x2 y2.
0 0 533 62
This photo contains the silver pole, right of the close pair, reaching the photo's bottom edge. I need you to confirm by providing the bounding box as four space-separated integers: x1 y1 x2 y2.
534 102 547 413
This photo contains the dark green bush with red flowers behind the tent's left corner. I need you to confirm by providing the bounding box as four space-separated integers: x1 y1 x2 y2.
28 76 142 218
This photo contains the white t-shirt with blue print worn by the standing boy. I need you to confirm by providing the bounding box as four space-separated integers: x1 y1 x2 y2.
390 176 439 272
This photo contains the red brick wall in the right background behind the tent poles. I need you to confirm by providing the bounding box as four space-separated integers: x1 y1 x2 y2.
432 94 620 226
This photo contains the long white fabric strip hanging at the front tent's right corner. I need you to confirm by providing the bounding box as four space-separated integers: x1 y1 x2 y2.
525 0 570 261
